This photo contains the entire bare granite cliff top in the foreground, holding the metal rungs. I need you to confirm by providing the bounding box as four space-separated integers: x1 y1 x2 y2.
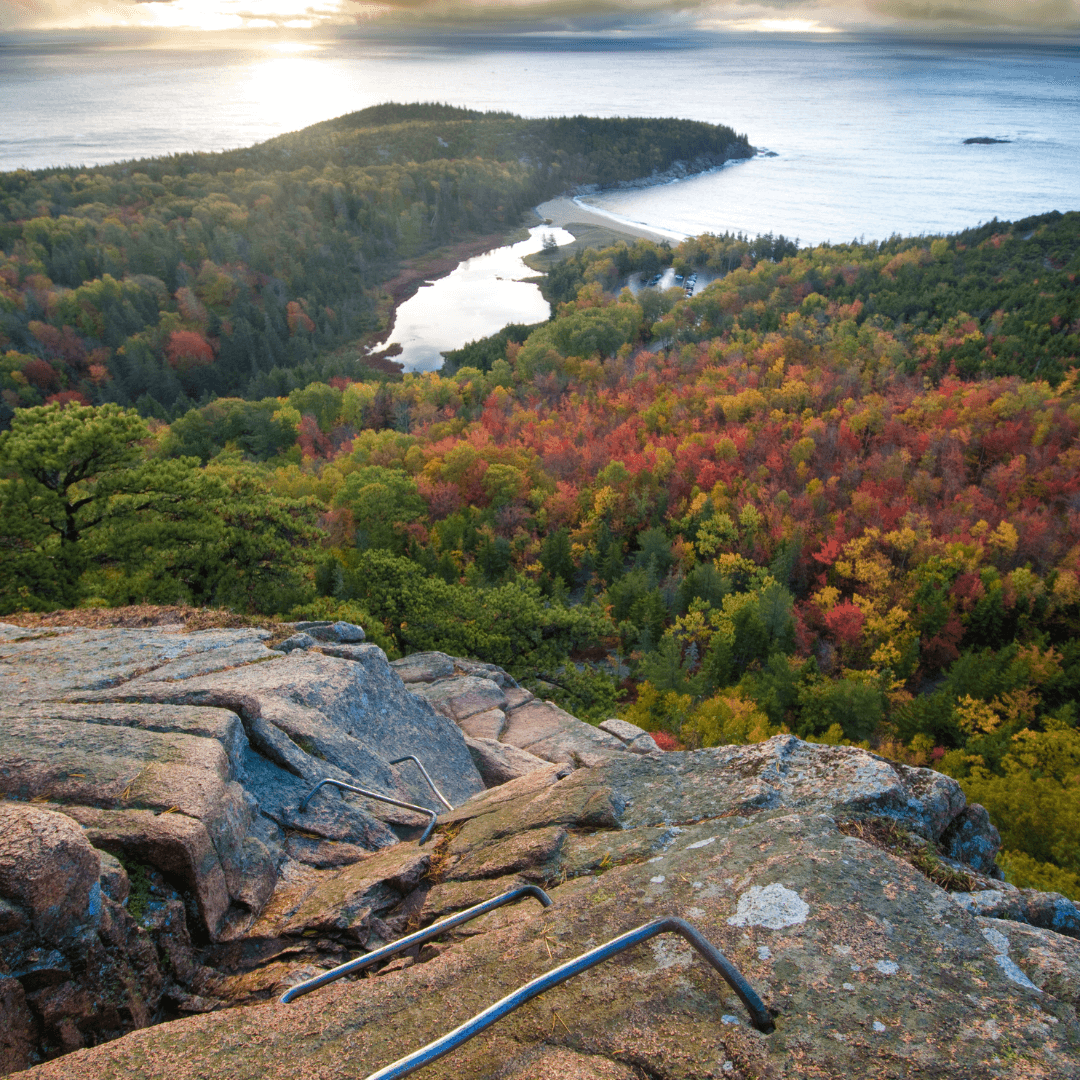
0 626 1080 1080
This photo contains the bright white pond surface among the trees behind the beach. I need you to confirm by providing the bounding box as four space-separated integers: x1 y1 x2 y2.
387 225 573 372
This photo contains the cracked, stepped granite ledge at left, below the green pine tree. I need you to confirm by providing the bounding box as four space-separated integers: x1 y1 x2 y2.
0 622 639 1071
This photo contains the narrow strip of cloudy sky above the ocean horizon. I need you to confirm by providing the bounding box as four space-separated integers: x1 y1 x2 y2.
0 0 1080 36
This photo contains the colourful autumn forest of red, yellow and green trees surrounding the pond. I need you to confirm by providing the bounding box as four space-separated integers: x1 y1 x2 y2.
0 113 1080 897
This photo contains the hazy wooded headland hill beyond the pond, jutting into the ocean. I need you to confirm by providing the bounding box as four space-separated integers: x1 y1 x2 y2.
0 105 752 427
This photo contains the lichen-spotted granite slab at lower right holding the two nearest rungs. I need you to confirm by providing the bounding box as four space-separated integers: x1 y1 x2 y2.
16 751 1080 1080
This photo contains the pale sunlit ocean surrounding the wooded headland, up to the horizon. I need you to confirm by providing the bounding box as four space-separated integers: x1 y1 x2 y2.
0 33 1080 243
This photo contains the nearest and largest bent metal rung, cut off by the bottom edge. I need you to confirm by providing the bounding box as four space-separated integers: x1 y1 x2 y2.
367 918 773 1080
